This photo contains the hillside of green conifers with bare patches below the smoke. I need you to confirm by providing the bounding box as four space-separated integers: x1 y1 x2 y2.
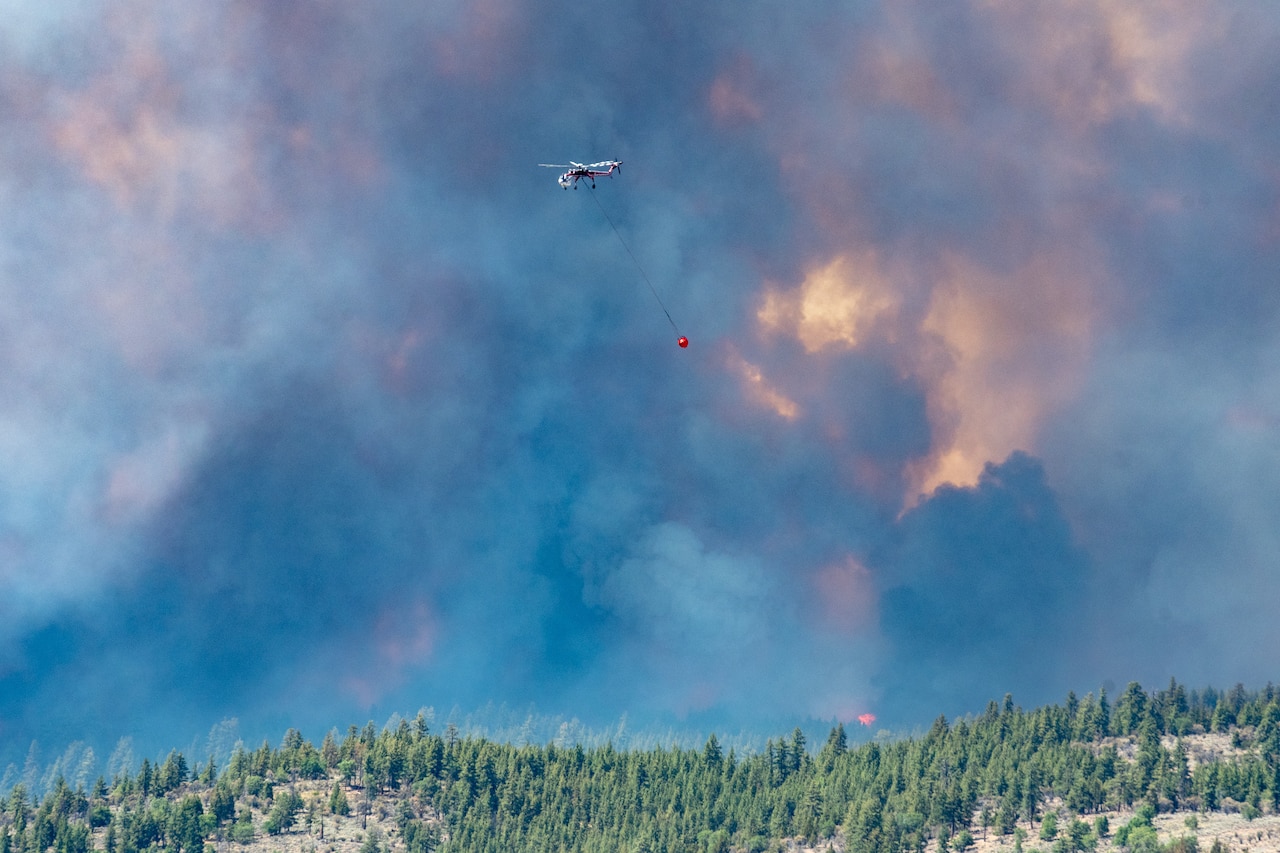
0 683 1280 853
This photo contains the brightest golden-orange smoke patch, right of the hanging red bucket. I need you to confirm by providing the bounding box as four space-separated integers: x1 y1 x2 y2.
744 238 1102 503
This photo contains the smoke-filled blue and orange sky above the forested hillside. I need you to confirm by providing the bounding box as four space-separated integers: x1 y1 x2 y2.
0 0 1280 762
